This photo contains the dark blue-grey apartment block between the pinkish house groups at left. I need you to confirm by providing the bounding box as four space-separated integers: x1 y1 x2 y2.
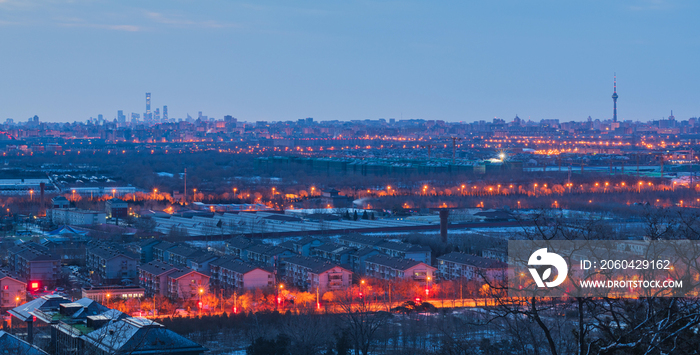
85 244 139 284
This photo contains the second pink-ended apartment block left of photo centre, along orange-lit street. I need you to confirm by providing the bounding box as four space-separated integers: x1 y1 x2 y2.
209 258 275 293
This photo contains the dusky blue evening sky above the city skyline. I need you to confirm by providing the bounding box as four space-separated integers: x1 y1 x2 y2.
0 0 700 122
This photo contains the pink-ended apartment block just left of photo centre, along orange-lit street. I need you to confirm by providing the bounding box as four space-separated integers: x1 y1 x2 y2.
284 255 352 292
